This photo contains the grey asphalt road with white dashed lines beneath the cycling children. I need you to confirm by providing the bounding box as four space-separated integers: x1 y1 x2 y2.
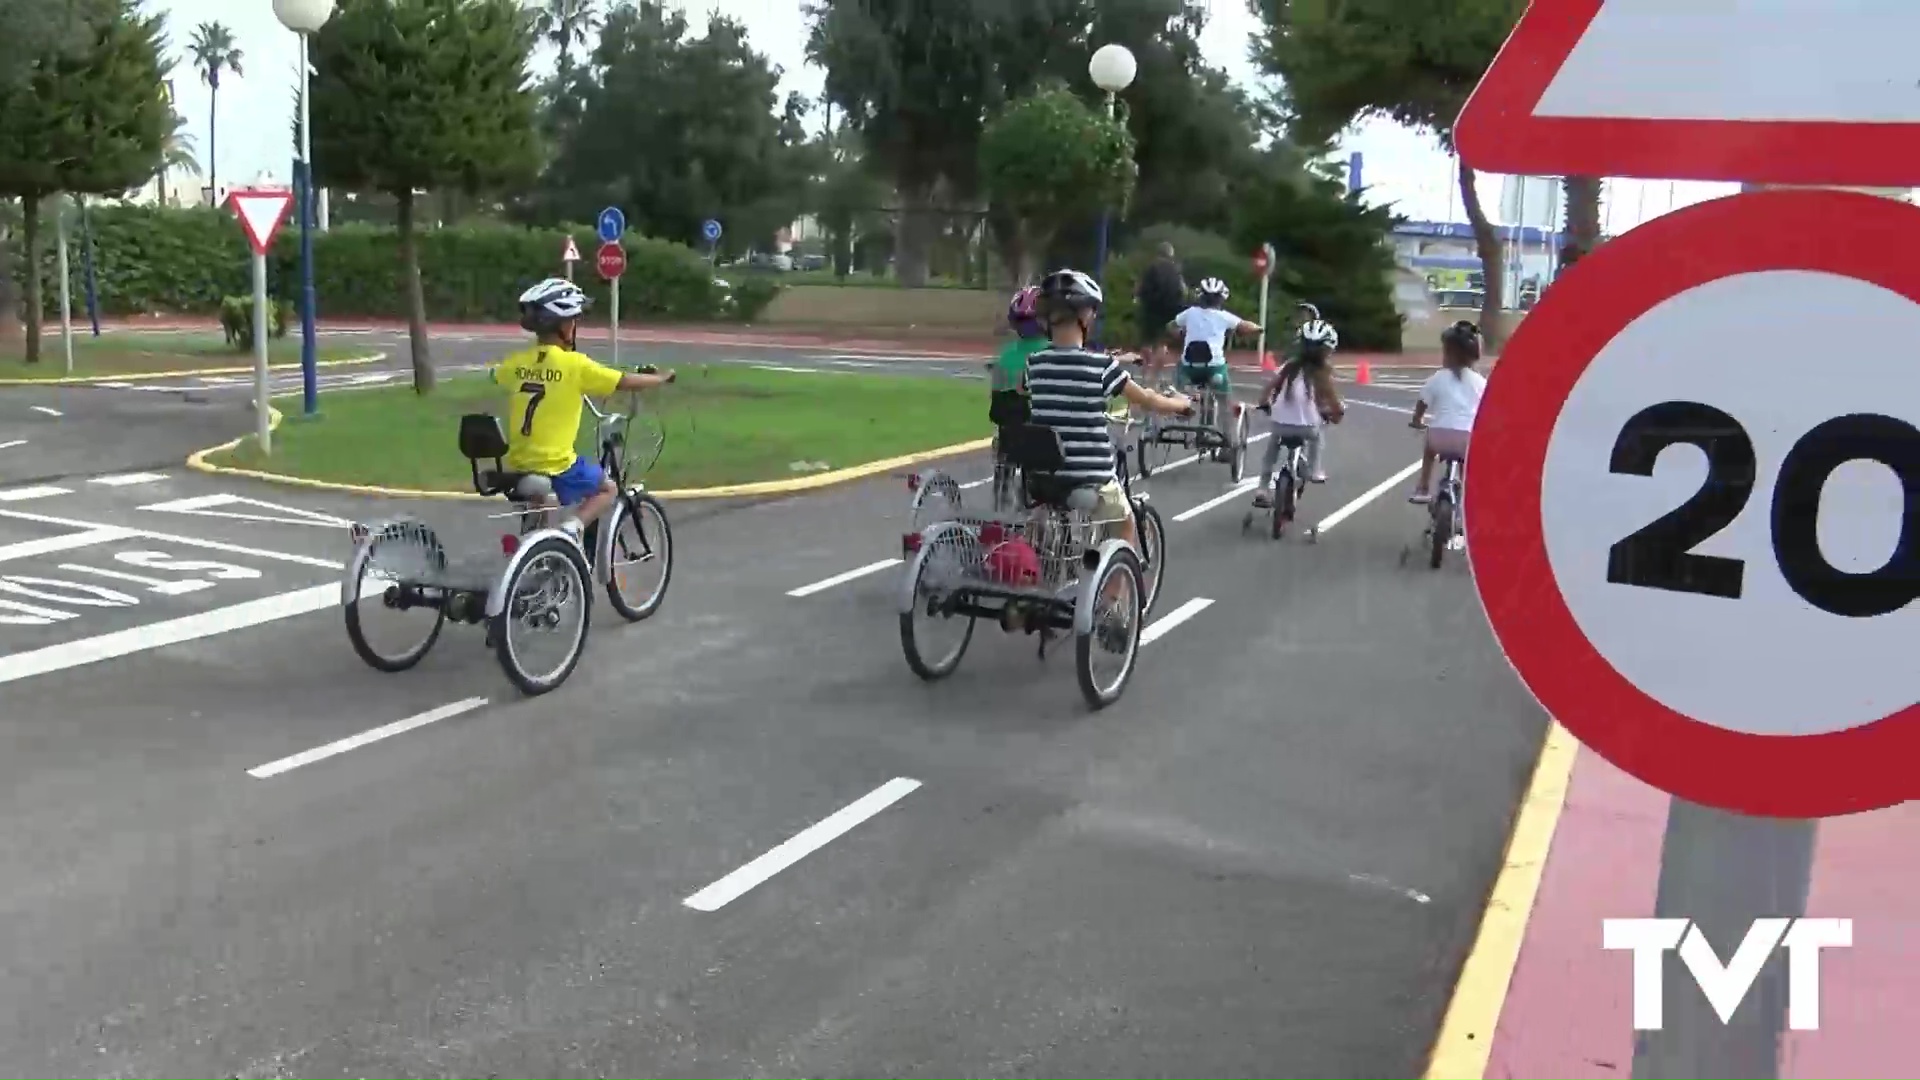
0 342 1546 1080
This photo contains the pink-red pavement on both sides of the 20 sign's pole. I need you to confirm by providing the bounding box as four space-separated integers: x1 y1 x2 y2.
1484 749 1920 1080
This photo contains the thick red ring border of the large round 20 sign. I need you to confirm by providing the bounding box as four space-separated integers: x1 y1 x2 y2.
1467 190 1920 817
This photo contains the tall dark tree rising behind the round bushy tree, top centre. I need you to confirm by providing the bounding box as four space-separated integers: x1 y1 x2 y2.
806 0 1091 286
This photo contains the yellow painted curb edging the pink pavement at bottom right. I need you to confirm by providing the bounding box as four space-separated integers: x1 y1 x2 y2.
1421 723 1580 1080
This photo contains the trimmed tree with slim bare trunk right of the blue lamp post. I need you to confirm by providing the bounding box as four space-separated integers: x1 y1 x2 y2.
309 0 538 394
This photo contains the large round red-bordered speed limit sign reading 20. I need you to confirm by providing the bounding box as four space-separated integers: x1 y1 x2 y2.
1465 190 1920 817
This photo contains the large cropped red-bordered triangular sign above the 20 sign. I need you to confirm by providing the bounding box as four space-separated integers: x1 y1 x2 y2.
1453 0 1920 186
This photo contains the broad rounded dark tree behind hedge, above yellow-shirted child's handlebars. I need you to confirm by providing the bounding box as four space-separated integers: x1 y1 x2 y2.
536 0 820 244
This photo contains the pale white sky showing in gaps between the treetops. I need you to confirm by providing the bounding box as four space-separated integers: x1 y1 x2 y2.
148 0 1738 234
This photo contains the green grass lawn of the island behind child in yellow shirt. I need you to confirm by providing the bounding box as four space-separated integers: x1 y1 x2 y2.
207 365 991 492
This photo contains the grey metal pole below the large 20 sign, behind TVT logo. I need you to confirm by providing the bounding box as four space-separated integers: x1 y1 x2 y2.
1632 799 1816 1080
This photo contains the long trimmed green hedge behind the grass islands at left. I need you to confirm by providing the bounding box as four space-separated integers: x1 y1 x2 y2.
13 206 774 323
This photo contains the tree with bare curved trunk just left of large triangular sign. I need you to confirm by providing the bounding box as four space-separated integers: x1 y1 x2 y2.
1254 0 1526 342
